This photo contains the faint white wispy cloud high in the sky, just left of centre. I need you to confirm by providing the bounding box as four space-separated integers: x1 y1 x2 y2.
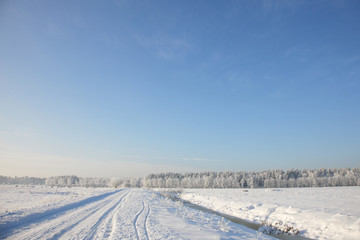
135 35 193 60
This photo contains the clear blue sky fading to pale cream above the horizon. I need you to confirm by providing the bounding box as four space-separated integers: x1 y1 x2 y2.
0 0 360 177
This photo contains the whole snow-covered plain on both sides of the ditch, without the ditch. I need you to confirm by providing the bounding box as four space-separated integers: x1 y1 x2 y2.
0 185 360 239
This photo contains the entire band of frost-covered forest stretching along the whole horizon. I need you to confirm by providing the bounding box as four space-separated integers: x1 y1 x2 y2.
0 168 360 188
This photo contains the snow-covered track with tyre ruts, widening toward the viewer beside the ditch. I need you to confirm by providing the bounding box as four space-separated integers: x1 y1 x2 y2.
0 189 272 239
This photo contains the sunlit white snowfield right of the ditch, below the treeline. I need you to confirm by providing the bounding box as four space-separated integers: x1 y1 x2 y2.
180 187 360 240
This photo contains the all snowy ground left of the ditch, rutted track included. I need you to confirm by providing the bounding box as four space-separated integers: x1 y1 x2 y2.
0 186 273 239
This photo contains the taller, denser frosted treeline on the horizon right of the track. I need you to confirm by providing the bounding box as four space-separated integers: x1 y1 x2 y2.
143 168 360 188
